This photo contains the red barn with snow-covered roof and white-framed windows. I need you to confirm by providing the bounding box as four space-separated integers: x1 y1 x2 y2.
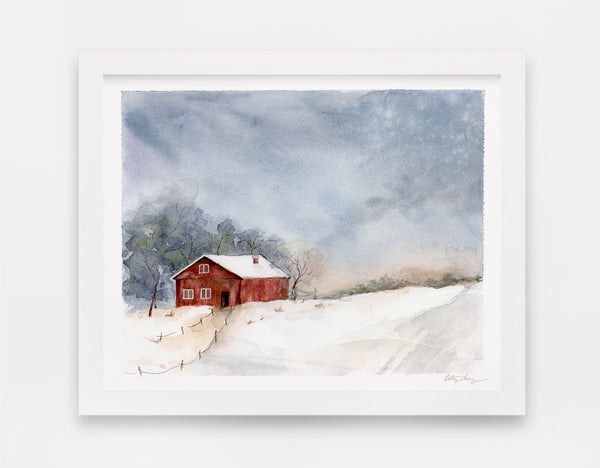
171 255 290 307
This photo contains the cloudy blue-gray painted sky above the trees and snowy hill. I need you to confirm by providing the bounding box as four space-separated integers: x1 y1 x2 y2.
122 90 484 282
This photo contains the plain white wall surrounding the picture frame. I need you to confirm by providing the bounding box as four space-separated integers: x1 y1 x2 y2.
0 0 600 467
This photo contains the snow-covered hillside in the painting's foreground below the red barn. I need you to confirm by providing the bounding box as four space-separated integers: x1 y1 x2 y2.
125 283 482 375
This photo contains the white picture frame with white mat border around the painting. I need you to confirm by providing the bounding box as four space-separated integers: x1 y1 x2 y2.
79 50 525 415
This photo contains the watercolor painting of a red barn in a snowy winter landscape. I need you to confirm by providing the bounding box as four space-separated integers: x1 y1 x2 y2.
121 89 485 379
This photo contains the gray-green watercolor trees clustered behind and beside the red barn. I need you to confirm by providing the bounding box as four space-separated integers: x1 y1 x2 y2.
122 189 323 315
